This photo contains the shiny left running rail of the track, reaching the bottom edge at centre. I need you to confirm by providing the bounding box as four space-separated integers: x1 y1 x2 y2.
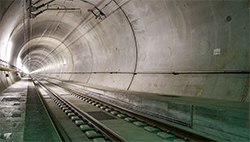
37 80 127 142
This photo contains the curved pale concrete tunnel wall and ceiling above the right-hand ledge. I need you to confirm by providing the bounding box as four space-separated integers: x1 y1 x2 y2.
0 0 250 101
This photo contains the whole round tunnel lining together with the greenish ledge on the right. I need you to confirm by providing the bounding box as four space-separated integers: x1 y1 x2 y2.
0 0 250 141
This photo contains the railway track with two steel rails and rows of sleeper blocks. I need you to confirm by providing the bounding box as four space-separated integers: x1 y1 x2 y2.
34 79 215 142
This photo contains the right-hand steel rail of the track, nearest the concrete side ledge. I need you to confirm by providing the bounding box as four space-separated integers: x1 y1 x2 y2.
46 80 216 142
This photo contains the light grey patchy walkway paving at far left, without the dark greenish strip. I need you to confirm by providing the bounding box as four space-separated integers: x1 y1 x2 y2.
0 78 30 142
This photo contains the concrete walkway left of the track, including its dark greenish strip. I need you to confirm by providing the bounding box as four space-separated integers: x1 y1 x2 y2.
0 77 60 142
